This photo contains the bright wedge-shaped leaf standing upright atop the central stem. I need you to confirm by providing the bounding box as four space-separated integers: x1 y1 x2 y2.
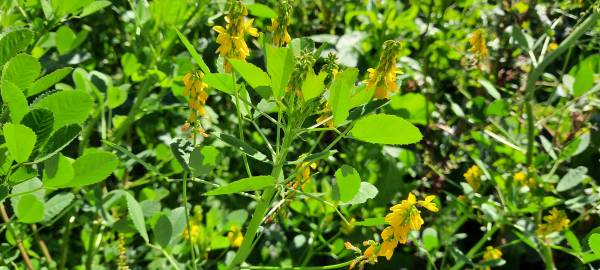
266 45 294 99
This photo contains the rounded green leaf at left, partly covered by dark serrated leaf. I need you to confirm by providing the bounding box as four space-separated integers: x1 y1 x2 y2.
33 90 93 130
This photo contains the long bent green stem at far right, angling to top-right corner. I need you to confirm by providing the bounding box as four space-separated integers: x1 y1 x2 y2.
525 12 598 167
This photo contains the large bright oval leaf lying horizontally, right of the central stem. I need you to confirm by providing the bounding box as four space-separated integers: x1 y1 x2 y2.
350 114 423 145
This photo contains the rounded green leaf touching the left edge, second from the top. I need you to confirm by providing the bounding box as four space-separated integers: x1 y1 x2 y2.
2 53 42 90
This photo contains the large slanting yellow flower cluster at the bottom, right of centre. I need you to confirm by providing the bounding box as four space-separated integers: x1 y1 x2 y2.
345 193 439 269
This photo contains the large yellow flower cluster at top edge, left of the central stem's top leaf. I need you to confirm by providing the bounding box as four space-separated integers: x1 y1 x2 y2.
213 1 258 72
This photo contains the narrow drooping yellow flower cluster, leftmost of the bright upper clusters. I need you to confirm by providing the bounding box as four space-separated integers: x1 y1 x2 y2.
183 71 208 122
